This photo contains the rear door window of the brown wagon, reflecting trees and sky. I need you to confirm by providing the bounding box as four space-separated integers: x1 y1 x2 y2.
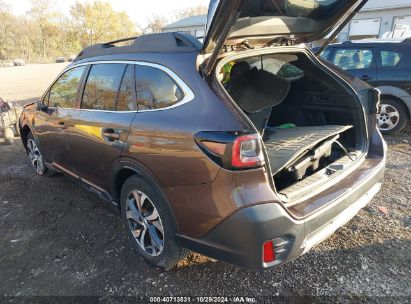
81 64 126 111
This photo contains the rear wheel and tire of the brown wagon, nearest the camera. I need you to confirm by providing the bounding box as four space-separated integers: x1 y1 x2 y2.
120 175 186 270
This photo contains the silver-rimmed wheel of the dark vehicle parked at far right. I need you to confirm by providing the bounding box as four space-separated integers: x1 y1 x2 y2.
377 98 408 135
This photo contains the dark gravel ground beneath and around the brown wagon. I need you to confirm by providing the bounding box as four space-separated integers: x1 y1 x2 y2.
0 63 411 303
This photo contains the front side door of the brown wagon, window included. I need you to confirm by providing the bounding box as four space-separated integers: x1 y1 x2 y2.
34 66 85 166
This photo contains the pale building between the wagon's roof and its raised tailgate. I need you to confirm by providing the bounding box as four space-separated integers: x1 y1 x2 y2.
163 15 207 40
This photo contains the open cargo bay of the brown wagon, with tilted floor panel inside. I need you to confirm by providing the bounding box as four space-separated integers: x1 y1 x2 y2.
219 52 364 204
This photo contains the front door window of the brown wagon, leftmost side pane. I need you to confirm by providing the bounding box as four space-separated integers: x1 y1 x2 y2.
49 66 85 108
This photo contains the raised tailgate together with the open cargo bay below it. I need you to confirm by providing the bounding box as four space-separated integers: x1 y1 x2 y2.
204 0 367 214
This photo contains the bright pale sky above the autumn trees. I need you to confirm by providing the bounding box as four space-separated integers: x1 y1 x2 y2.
5 0 210 27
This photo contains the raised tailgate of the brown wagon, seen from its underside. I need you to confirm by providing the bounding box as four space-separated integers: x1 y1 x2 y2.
203 0 367 53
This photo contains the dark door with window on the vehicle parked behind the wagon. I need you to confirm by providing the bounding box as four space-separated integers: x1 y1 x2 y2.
331 47 377 83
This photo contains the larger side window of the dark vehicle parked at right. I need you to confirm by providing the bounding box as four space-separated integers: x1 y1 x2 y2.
333 49 373 70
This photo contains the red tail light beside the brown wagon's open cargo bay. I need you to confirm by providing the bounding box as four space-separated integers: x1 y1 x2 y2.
231 134 264 168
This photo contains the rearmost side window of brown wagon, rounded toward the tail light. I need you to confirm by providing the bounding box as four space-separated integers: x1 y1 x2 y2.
136 65 183 110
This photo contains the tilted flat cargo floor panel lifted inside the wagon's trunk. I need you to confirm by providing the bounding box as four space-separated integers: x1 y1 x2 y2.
264 125 352 174
